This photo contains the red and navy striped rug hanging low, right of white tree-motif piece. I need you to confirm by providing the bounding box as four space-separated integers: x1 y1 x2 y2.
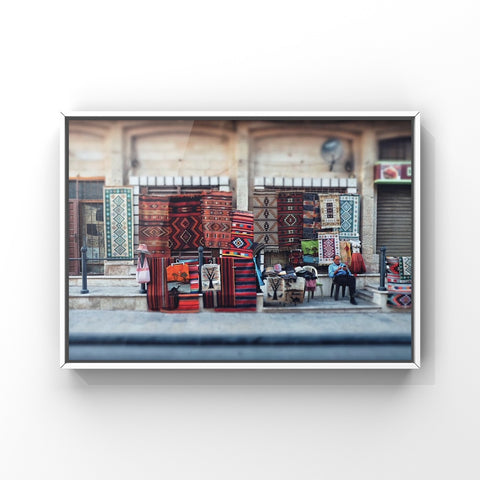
216 257 257 312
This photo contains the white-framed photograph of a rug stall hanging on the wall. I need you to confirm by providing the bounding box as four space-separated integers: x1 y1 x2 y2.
60 111 420 369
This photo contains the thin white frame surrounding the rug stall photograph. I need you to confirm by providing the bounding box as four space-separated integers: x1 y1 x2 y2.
59 111 421 370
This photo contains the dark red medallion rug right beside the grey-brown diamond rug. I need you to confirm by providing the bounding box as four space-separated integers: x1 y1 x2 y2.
278 192 303 250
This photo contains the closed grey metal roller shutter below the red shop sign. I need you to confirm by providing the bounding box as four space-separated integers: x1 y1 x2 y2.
377 185 413 256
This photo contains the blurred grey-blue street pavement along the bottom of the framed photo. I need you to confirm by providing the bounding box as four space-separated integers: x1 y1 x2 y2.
69 310 411 362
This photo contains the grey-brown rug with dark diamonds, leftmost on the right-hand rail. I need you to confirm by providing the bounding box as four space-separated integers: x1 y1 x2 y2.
253 192 278 251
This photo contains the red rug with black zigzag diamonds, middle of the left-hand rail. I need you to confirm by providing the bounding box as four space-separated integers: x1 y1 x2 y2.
168 195 205 250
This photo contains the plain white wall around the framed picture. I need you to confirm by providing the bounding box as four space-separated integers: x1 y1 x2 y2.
0 0 480 480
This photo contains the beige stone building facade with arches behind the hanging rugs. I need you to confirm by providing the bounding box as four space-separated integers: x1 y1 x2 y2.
66 118 413 274
